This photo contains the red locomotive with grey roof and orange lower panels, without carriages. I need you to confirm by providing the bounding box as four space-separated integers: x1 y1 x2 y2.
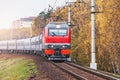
43 22 71 60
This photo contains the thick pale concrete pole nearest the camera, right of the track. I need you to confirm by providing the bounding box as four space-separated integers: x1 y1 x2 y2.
90 0 97 70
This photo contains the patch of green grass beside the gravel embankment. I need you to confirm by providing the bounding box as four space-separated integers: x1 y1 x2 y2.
0 58 38 80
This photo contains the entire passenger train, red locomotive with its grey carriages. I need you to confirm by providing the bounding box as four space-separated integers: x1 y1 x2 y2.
0 22 71 61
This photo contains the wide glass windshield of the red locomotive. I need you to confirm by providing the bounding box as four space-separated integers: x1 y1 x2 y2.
49 29 67 36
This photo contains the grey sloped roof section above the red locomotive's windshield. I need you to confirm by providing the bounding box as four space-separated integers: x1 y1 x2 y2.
46 22 69 28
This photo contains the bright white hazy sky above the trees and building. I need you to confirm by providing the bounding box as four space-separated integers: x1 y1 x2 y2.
0 0 74 29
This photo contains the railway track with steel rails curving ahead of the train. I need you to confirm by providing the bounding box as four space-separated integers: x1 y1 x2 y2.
52 62 120 80
